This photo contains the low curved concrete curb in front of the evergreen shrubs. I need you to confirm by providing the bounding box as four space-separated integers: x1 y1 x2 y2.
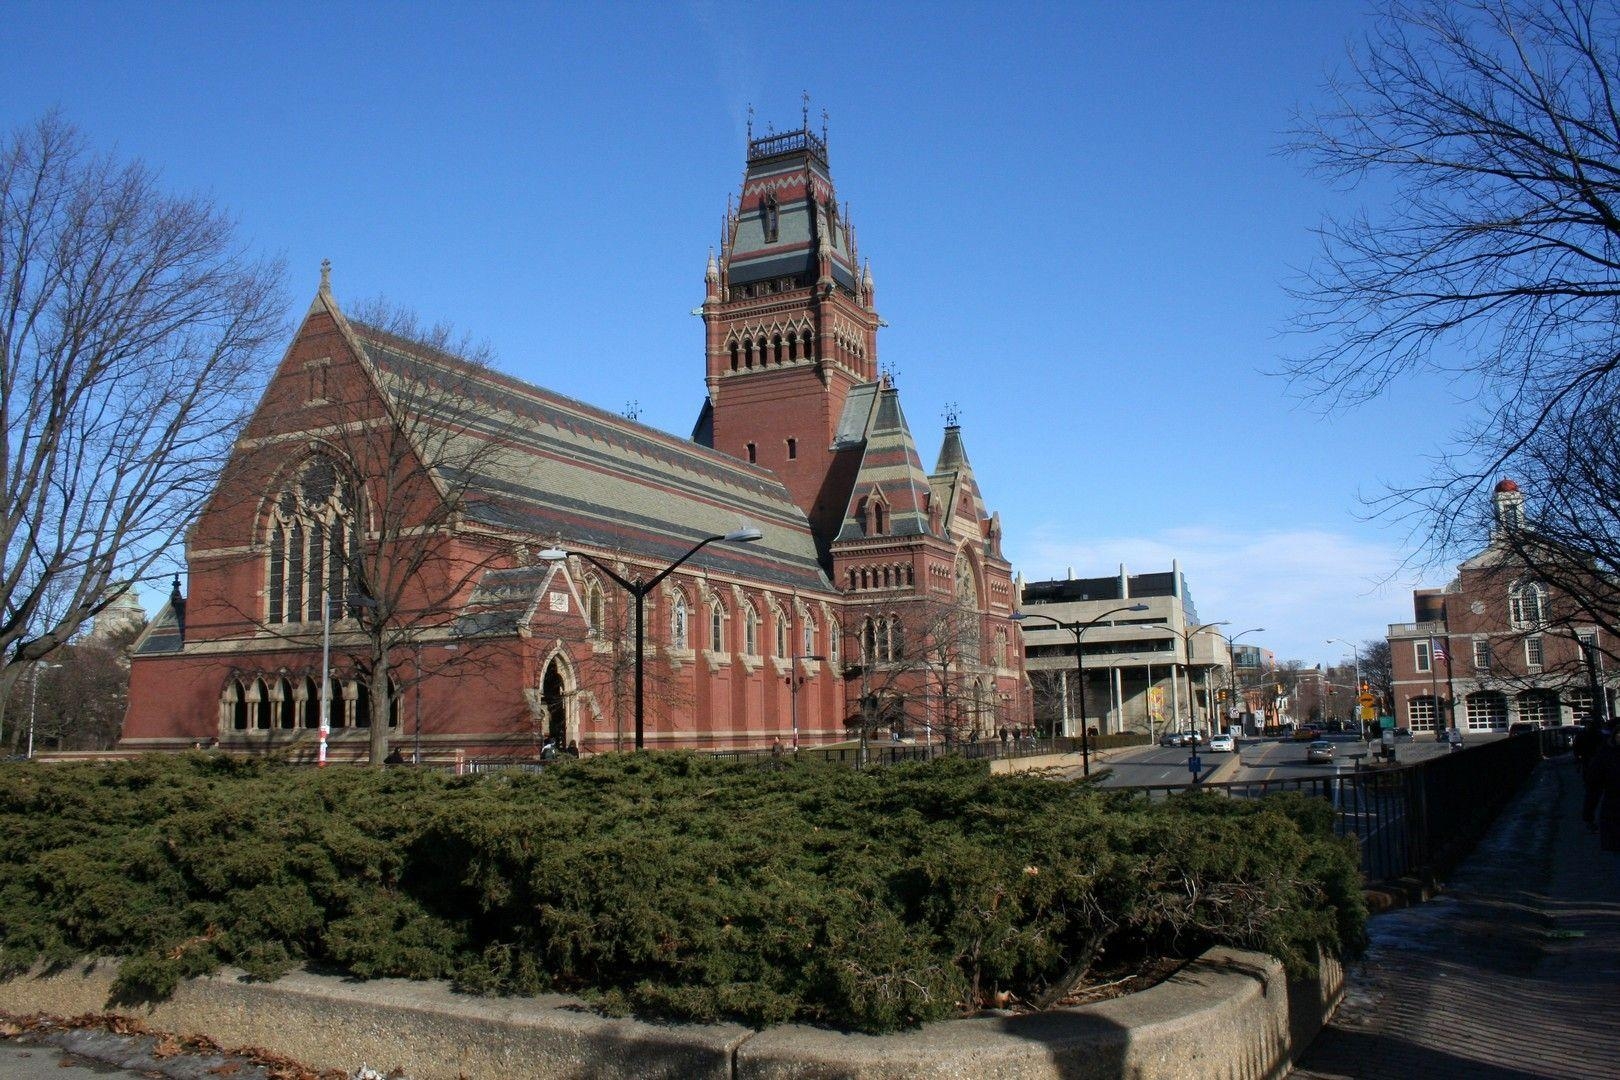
0 949 1343 1080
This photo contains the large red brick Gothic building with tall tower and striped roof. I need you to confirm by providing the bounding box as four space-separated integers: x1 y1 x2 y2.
123 122 1027 759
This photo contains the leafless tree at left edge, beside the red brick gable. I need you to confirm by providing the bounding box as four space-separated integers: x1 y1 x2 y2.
0 115 282 735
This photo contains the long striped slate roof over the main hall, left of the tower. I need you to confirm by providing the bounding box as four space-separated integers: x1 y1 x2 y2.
354 317 831 589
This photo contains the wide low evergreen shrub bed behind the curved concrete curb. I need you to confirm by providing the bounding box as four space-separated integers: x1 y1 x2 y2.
0 753 1366 1031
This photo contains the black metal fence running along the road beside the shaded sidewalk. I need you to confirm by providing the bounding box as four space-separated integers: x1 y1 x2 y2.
1119 730 1542 881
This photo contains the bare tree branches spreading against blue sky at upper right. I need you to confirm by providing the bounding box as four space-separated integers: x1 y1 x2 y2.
1290 0 1620 557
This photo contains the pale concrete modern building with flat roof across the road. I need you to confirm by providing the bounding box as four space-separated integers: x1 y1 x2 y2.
1019 562 1230 735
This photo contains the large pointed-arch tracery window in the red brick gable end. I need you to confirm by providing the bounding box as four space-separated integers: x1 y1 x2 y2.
266 453 358 623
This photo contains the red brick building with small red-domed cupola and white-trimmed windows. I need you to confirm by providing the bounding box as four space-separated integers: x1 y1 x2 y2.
1390 479 1615 732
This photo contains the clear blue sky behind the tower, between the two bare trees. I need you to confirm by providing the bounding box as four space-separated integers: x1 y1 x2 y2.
0 0 1458 662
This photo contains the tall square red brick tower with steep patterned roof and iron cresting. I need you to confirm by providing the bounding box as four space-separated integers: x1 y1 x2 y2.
695 123 880 554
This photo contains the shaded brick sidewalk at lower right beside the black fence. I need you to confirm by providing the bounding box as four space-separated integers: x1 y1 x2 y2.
1291 755 1620 1080
